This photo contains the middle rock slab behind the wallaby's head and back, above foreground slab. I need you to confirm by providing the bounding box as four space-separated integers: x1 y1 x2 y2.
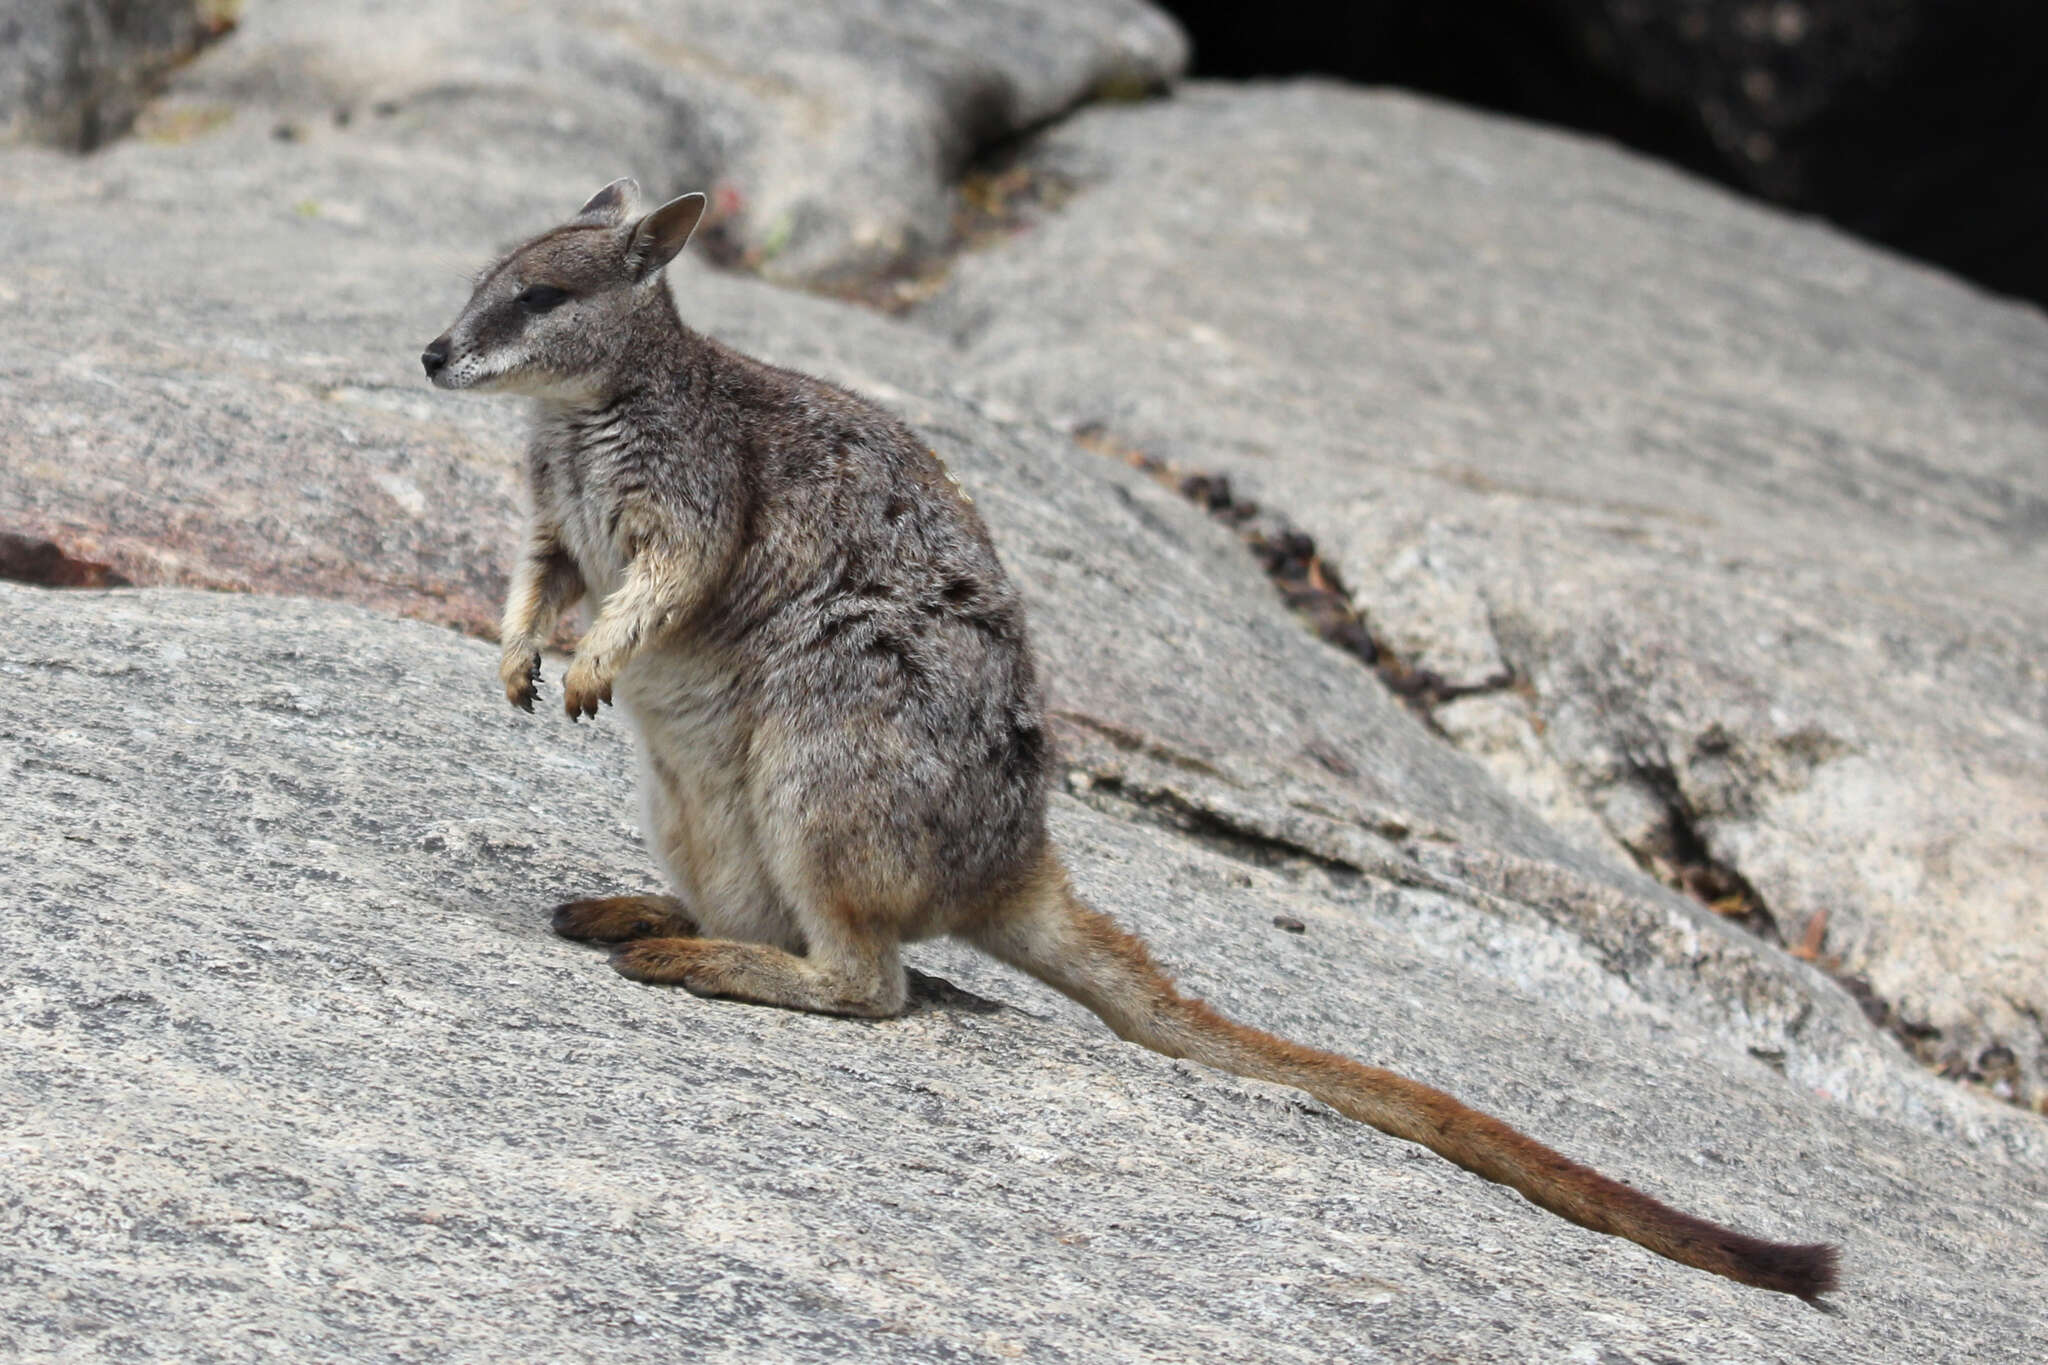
0 90 1970 1124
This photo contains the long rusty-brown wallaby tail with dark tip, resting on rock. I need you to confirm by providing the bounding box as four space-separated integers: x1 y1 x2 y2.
969 860 1835 1302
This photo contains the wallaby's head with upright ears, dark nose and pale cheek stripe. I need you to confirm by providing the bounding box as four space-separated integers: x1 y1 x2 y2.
420 180 705 401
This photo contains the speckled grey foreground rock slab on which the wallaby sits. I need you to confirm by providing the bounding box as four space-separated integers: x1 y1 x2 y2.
0 585 2048 1363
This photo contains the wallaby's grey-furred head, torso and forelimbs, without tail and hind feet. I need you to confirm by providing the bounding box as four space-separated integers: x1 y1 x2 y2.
430 182 1049 1013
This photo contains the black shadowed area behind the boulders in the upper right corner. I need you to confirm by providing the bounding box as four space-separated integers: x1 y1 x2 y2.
1161 0 2048 305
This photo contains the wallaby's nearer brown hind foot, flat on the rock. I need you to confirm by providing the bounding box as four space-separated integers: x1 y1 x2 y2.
612 933 907 1019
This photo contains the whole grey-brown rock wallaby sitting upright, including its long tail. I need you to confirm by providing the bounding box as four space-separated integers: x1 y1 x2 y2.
422 180 1835 1302
